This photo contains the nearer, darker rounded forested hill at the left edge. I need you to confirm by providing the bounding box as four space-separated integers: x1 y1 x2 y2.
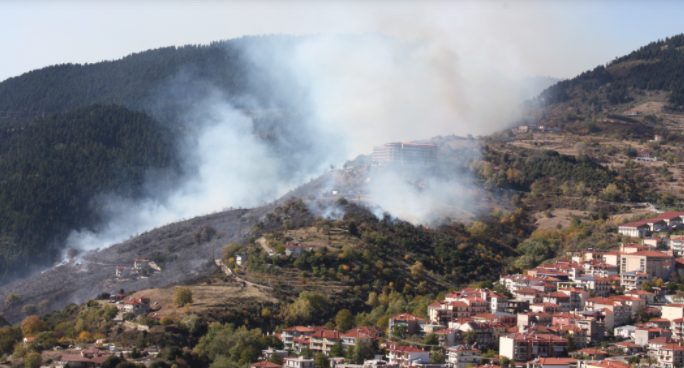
0 105 178 280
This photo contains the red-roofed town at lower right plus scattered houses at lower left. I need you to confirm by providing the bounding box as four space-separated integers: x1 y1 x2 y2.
8 212 684 368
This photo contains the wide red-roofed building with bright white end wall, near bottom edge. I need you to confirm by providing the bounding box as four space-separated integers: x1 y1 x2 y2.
499 333 568 362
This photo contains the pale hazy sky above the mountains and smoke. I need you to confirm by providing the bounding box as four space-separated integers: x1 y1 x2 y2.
0 0 684 80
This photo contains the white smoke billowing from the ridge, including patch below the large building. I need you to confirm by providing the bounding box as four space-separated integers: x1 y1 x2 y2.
67 25 536 249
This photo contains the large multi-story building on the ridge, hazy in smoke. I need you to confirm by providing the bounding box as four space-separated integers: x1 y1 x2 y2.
373 142 437 165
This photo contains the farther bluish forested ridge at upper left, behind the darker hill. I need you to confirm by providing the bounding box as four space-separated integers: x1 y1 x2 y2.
0 42 246 118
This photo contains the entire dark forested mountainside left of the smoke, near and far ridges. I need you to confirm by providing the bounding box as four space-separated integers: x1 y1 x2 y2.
0 36 310 283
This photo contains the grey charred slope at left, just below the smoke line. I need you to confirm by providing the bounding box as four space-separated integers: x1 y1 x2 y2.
0 207 269 322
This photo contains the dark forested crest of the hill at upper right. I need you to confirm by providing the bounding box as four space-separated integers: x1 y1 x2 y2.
540 34 684 110
